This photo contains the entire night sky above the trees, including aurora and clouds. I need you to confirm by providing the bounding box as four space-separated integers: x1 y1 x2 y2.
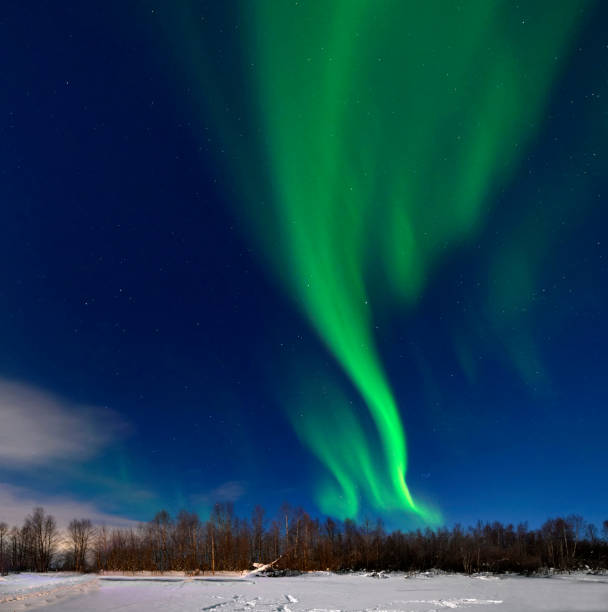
0 0 608 527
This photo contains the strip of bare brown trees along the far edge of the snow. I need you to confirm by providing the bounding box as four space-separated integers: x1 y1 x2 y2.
0 504 608 574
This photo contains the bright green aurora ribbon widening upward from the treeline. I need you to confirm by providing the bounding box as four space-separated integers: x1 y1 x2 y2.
163 0 582 524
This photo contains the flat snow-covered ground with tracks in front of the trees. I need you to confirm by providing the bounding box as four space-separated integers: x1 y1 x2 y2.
0 573 608 612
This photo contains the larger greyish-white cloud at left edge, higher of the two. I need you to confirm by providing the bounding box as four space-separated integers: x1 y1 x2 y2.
0 379 126 467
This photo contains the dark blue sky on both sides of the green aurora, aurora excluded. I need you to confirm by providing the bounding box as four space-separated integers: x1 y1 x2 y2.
0 2 608 524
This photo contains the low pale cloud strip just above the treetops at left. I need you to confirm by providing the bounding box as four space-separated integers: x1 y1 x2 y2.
0 483 138 529
